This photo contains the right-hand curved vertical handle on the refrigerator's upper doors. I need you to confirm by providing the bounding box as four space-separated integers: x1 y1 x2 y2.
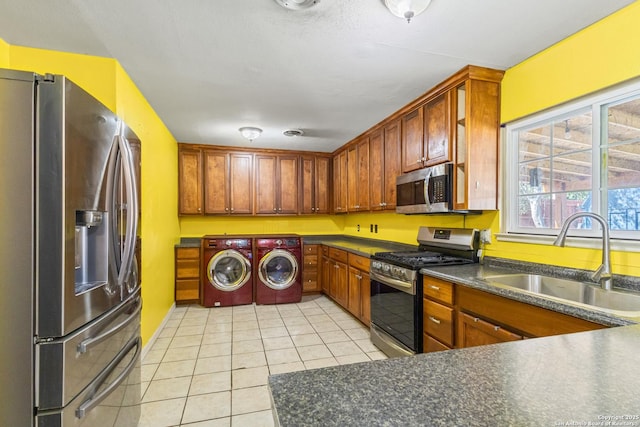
117 132 138 287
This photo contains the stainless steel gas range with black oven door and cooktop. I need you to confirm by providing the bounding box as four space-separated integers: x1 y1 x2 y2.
370 227 479 357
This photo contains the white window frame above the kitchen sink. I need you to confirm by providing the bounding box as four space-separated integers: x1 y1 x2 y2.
498 79 640 246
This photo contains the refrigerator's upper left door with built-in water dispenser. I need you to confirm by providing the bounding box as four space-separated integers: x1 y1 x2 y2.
35 76 137 338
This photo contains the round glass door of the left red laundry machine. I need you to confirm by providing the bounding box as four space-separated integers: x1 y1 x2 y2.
207 249 251 292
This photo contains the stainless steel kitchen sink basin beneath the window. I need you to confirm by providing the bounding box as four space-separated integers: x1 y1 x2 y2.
484 273 640 317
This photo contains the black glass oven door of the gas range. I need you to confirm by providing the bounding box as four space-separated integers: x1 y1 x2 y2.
371 273 422 357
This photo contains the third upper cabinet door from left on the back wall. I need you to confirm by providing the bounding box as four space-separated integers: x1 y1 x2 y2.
229 153 253 214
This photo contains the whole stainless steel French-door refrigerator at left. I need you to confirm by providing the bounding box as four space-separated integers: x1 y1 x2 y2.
0 69 142 427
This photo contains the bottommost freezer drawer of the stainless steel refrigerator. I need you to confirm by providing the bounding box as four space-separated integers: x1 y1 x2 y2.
35 330 142 427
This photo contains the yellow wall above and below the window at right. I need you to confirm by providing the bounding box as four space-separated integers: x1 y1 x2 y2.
487 2 640 276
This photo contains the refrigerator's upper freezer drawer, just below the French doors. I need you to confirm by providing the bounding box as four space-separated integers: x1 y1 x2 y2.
36 295 142 411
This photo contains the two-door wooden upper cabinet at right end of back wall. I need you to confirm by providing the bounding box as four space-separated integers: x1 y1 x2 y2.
300 155 331 214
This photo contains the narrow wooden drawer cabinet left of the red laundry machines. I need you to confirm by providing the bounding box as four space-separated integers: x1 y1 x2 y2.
175 247 200 304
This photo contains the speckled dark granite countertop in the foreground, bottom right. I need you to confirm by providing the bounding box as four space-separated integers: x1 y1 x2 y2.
269 325 640 427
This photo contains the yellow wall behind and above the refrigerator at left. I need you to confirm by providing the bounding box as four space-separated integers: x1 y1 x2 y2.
5 43 180 343
